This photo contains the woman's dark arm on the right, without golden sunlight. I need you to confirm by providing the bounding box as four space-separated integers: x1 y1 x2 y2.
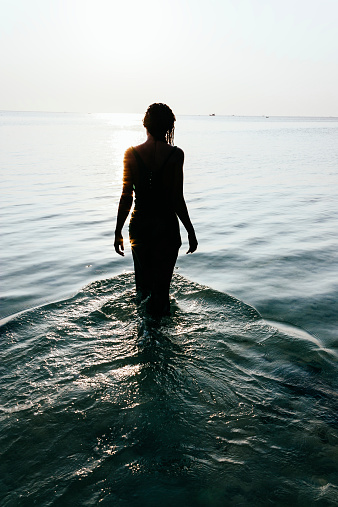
174 150 198 253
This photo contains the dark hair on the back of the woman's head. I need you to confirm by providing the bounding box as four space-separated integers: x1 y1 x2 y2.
143 103 176 144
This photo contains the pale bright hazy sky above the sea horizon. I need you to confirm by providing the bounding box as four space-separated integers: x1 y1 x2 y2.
0 0 338 116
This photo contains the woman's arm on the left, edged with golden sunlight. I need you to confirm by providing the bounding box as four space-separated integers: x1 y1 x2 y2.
114 149 133 255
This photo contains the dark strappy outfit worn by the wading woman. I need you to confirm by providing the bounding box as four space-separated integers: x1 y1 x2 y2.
129 147 182 315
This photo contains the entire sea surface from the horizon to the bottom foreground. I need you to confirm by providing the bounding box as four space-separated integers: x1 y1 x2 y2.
0 112 338 507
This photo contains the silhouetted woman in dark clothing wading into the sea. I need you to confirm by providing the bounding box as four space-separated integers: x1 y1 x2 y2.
114 104 197 315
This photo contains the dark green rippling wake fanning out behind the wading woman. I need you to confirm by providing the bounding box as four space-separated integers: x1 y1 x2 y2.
0 274 338 507
